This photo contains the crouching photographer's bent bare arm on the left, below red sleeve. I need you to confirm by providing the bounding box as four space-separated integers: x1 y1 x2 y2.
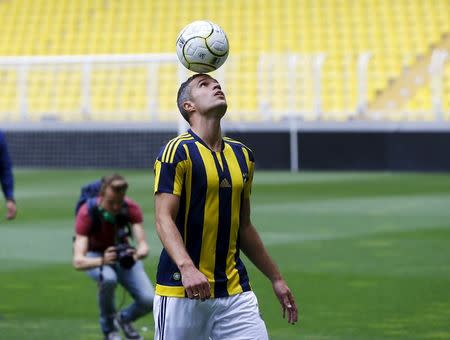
73 234 116 270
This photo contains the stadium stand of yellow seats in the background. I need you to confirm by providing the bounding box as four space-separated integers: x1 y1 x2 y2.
0 0 450 121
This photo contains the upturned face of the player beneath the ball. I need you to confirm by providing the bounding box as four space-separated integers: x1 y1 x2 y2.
190 75 227 116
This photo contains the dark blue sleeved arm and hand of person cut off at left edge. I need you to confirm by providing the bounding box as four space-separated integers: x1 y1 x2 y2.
0 131 17 220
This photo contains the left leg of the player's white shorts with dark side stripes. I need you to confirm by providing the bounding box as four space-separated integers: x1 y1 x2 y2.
153 295 212 340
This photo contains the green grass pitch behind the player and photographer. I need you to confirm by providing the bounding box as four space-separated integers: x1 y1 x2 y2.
0 169 450 340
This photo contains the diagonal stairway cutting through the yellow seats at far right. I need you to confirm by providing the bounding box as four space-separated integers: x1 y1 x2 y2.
369 34 450 111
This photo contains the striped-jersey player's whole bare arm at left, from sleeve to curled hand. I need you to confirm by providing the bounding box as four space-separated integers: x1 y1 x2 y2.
155 193 211 300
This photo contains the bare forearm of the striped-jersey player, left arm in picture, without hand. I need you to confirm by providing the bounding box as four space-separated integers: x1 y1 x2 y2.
156 217 193 271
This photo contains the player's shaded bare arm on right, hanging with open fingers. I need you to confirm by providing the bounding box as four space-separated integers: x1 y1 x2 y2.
239 198 298 323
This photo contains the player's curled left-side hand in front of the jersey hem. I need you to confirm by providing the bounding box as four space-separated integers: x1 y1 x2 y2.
181 264 211 301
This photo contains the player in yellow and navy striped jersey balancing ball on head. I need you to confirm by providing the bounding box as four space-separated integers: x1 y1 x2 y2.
153 74 297 340
